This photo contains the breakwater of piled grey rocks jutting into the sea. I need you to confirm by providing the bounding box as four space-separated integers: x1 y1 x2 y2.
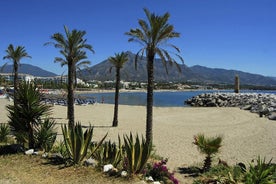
185 93 276 120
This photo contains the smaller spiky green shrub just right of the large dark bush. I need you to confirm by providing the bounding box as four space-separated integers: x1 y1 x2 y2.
35 118 57 152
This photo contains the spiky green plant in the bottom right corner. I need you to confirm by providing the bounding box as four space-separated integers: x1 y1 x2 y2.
245 156 276 184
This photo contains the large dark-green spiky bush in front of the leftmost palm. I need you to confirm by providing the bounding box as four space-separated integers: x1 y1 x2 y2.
7 83 51 148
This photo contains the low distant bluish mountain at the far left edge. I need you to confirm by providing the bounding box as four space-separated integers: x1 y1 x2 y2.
0 63 57 77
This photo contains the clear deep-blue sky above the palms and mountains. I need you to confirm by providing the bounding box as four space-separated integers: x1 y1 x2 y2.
0 0 276 76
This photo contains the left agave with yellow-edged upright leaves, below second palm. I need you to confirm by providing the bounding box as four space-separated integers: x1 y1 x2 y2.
61 122 93 164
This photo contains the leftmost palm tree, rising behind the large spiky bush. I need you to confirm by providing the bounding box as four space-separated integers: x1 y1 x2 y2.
3 44 32 105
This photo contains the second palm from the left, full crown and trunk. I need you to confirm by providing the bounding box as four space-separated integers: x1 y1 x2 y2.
46 26 94 128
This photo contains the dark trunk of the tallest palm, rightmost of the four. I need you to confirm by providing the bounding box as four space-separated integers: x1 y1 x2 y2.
146 54 154 144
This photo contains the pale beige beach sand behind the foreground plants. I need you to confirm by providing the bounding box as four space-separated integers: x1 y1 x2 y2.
0 99 276 183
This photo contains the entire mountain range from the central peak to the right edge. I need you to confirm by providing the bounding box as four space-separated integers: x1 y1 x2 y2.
78 52 276 86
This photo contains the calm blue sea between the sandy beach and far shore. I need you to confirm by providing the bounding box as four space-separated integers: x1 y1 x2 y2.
82 90 276 107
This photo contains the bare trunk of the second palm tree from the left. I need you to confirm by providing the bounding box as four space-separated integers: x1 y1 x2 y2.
67 62 75 128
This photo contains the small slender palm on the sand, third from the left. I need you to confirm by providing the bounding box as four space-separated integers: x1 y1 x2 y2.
109 52 128 127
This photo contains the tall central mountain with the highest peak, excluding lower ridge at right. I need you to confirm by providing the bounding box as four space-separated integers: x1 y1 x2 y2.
79 52 200 82
